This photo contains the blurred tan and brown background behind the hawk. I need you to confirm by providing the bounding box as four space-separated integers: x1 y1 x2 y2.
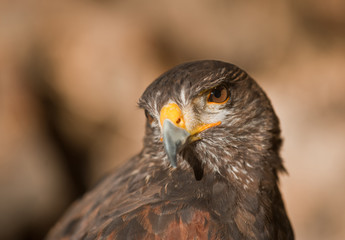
0 0 345 240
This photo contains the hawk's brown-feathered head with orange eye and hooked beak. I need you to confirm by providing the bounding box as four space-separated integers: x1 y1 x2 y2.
139 61 283 181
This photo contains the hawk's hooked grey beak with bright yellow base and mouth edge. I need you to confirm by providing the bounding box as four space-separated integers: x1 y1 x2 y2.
160 103 221 168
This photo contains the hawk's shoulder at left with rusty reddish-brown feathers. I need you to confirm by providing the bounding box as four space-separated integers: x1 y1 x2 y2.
48 158 228 239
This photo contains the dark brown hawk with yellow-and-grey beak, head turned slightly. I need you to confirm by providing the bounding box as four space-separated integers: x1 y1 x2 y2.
47 60 294 240
